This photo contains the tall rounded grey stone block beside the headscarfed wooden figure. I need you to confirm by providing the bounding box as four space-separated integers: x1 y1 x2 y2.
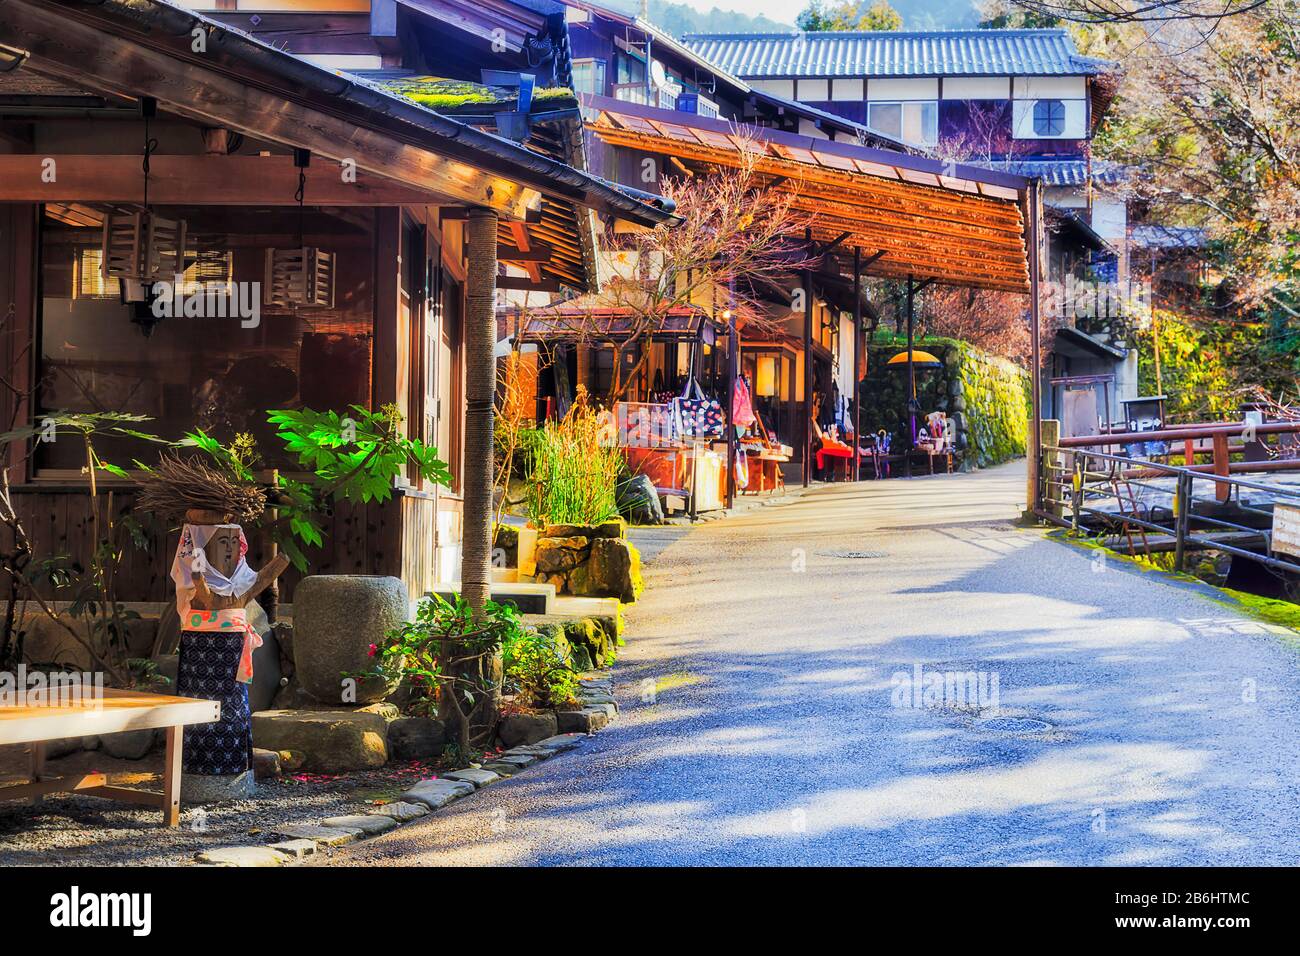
294 575 410 704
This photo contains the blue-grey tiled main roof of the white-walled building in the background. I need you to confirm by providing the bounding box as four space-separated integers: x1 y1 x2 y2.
683 30 1112 79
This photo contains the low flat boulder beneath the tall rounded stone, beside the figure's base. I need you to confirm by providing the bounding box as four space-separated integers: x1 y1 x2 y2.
252 710 389 774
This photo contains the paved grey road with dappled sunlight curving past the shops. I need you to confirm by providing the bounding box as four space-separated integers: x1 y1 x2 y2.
316 466 1300 865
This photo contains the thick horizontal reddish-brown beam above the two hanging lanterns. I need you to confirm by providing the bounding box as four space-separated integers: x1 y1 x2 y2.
0 153 455 206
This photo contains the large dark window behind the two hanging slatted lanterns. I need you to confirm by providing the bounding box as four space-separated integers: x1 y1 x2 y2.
35 209 374 476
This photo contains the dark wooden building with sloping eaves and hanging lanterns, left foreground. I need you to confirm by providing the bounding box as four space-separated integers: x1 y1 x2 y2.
0 0 671 601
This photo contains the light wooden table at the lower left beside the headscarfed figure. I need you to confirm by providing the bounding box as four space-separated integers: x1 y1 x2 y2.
0 688 221 826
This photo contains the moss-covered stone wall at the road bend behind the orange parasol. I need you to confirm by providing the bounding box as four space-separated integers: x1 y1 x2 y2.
861 334 1030 470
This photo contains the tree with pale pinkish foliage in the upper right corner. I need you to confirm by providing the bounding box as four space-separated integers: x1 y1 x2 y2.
1095 0 1300 320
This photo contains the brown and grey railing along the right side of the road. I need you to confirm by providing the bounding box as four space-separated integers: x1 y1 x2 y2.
1035 421 1300 574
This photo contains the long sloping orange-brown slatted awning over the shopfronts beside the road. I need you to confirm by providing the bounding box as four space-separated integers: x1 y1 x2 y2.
580 95 1030 293
